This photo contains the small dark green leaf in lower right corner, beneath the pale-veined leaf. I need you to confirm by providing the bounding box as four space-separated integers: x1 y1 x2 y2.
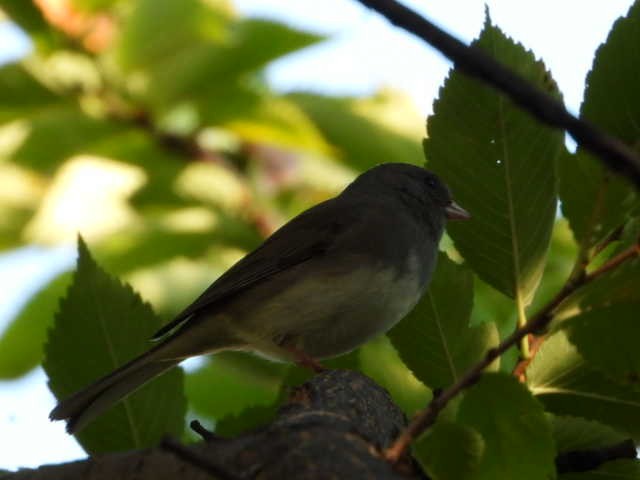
551 416 628 452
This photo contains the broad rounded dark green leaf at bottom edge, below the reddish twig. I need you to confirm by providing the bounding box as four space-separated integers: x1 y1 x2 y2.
457 373 555 480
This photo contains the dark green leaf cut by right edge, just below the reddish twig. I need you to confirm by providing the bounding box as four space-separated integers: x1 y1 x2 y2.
563 303 640 387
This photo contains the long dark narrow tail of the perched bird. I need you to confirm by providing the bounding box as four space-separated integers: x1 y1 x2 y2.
49 345 182 433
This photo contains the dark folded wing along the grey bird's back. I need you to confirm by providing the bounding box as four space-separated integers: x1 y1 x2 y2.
152 199 362 340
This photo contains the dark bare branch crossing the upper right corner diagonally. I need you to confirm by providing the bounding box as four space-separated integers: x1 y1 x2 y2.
358 0 640 188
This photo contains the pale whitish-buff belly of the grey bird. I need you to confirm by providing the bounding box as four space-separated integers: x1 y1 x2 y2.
232 255 423 359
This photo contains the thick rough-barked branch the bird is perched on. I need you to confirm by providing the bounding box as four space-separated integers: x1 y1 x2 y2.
3 370 426 480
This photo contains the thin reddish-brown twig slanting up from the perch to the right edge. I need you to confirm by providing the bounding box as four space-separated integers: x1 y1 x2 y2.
384 244 640 463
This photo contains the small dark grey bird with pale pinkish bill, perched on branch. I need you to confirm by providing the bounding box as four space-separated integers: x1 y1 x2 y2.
50 163 470 433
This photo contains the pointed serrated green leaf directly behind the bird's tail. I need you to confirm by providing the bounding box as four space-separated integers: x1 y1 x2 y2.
43 239 186 454
